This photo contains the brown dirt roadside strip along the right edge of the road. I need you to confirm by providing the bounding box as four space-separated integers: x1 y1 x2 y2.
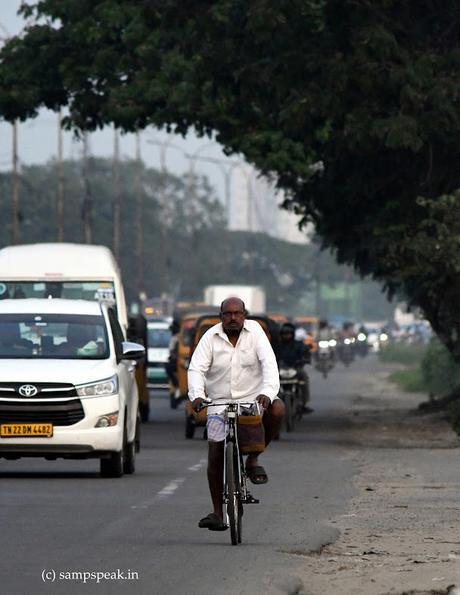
297 370 460 595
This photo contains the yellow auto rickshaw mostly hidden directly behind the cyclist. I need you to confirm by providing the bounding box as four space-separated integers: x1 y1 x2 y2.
185 314 279 439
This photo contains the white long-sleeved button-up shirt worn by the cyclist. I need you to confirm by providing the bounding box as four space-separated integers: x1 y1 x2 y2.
188 320 279 404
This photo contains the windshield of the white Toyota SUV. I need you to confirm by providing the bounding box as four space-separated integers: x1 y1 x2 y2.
0 314 109 359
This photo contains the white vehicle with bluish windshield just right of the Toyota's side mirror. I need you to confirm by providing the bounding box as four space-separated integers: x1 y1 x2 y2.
147 321 171 388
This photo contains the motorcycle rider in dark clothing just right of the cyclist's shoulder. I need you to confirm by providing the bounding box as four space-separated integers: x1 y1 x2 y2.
275 322 313 413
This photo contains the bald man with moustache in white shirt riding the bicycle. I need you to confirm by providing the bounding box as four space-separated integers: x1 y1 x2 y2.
188 297 284 531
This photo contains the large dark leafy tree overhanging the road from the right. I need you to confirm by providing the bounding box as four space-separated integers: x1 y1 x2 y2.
0 0 460 354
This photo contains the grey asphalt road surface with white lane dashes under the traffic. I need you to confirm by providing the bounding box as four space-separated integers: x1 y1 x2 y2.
0 356 378 595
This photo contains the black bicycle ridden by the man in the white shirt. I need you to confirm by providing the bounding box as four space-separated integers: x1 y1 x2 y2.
203 399 260 545
